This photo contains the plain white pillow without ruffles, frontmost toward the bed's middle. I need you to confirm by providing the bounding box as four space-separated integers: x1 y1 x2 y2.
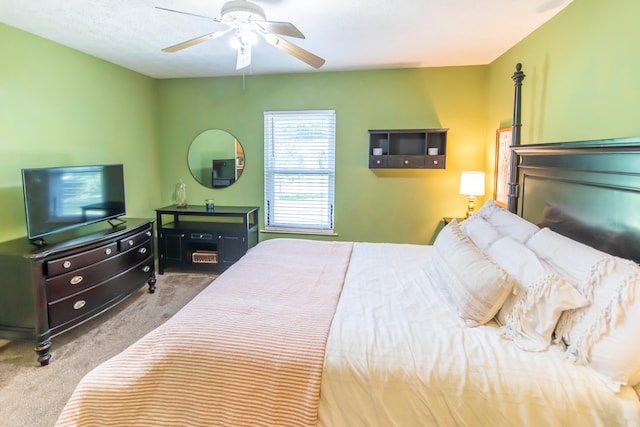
427 220 514 326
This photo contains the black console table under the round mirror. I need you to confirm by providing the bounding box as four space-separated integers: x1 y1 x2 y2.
156 205 259 274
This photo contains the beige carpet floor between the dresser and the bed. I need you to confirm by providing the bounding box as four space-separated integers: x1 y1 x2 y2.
0 273 215 427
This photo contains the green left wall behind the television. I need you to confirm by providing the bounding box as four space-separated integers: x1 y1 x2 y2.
0 24 160 241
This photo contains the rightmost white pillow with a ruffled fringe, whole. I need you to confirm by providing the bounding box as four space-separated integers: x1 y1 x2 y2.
527 228 640 391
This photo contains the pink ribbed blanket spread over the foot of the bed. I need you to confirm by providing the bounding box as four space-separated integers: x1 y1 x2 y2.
57 239 352 426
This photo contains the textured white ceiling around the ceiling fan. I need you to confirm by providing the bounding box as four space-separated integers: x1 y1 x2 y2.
0 0 573 78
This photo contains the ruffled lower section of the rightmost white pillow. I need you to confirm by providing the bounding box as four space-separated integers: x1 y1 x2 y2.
562 257 640 391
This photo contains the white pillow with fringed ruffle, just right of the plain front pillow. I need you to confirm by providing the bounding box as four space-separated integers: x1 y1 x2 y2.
487 236 588 351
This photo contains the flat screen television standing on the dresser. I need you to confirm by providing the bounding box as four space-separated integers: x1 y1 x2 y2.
22 164 126 244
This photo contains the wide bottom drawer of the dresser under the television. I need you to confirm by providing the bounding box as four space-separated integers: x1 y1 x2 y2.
47 256 154 328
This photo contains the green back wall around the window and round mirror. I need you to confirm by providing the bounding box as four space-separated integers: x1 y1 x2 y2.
159 67 487 243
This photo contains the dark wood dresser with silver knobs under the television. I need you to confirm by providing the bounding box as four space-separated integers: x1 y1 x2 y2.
0 218 156 365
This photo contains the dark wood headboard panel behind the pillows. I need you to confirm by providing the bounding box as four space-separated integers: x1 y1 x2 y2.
512 138 640 262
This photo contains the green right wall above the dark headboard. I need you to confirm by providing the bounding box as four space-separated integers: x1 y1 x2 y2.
487 0 640 157
